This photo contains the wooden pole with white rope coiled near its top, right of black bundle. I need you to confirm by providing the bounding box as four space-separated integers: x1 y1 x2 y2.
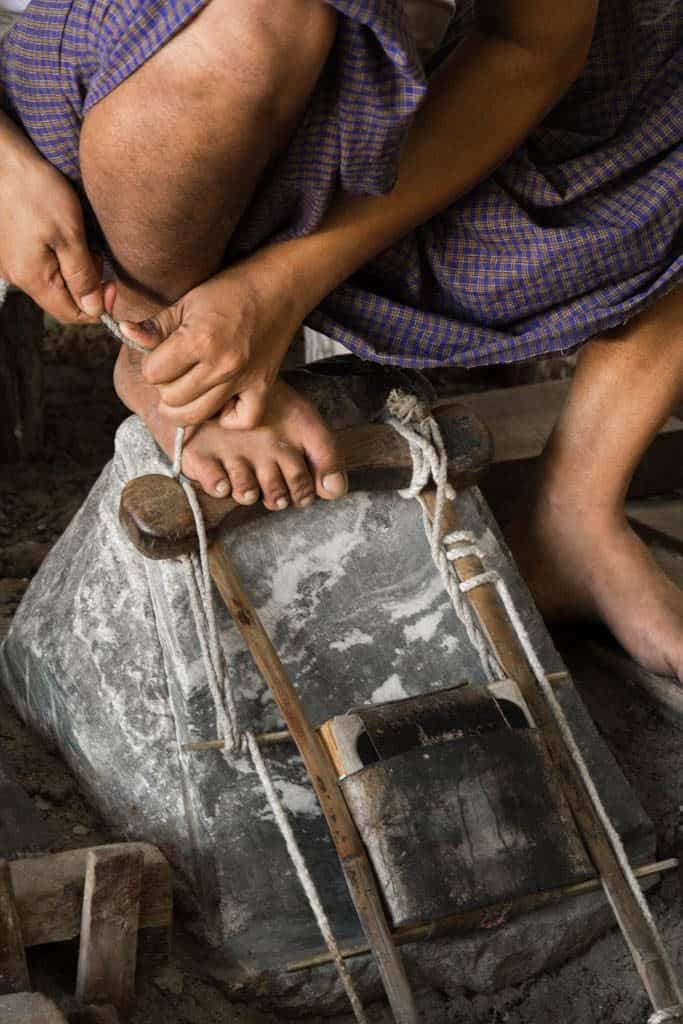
422 488 683 1010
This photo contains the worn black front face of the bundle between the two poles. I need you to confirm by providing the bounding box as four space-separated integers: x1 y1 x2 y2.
341 722 593 928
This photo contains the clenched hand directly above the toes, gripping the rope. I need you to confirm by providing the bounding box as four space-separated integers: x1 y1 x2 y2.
121 253 305 430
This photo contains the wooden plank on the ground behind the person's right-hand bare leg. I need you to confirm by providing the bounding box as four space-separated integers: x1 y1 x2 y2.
458 380 683 521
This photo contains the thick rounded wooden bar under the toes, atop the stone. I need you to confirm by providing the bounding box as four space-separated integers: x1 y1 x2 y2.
119 404 493 559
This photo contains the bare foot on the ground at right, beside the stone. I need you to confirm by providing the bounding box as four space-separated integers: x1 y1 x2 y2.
506 498 683 682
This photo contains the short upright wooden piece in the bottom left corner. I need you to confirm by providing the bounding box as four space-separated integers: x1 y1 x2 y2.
76 847 142 1015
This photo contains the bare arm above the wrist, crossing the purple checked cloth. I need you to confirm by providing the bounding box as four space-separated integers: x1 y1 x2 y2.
264 17 590 316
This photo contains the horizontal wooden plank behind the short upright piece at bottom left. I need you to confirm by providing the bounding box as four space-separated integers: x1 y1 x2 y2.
9 843 173 946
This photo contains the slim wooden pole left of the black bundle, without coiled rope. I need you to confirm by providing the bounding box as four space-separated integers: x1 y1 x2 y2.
209 544 418 1024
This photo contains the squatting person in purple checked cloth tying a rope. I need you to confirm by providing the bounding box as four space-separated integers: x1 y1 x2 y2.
0 0 683 681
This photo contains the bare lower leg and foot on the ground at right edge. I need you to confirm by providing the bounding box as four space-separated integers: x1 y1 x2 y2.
508 288 683 681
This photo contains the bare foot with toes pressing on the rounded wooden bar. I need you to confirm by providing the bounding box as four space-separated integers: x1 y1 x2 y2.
115 349 347 512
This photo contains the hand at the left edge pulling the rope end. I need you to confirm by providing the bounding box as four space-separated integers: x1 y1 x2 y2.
0 114 103 324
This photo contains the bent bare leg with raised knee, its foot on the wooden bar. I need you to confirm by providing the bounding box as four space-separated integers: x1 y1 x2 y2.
81 0 345 509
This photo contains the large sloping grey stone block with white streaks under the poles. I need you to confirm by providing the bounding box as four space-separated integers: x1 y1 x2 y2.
0 419 653 1002
